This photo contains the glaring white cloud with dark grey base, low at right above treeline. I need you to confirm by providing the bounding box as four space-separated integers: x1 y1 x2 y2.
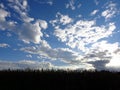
82 41 120 70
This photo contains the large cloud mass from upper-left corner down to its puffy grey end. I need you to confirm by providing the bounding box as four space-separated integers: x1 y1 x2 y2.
0 0 47 43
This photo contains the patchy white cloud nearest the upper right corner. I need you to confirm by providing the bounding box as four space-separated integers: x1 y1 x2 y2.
101 2 118 20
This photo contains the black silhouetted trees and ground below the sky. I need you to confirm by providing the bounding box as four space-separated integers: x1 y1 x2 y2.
0 70 120 90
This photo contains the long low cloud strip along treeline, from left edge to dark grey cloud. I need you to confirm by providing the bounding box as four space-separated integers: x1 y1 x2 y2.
0 60 94 70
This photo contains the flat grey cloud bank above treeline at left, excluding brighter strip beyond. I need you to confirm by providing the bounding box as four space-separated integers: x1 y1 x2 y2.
0 60 54 70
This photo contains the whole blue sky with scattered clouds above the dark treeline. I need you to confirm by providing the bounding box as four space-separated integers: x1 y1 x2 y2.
0 0 120 71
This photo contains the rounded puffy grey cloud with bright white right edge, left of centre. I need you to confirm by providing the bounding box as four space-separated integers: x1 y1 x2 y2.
17 20 47 43
